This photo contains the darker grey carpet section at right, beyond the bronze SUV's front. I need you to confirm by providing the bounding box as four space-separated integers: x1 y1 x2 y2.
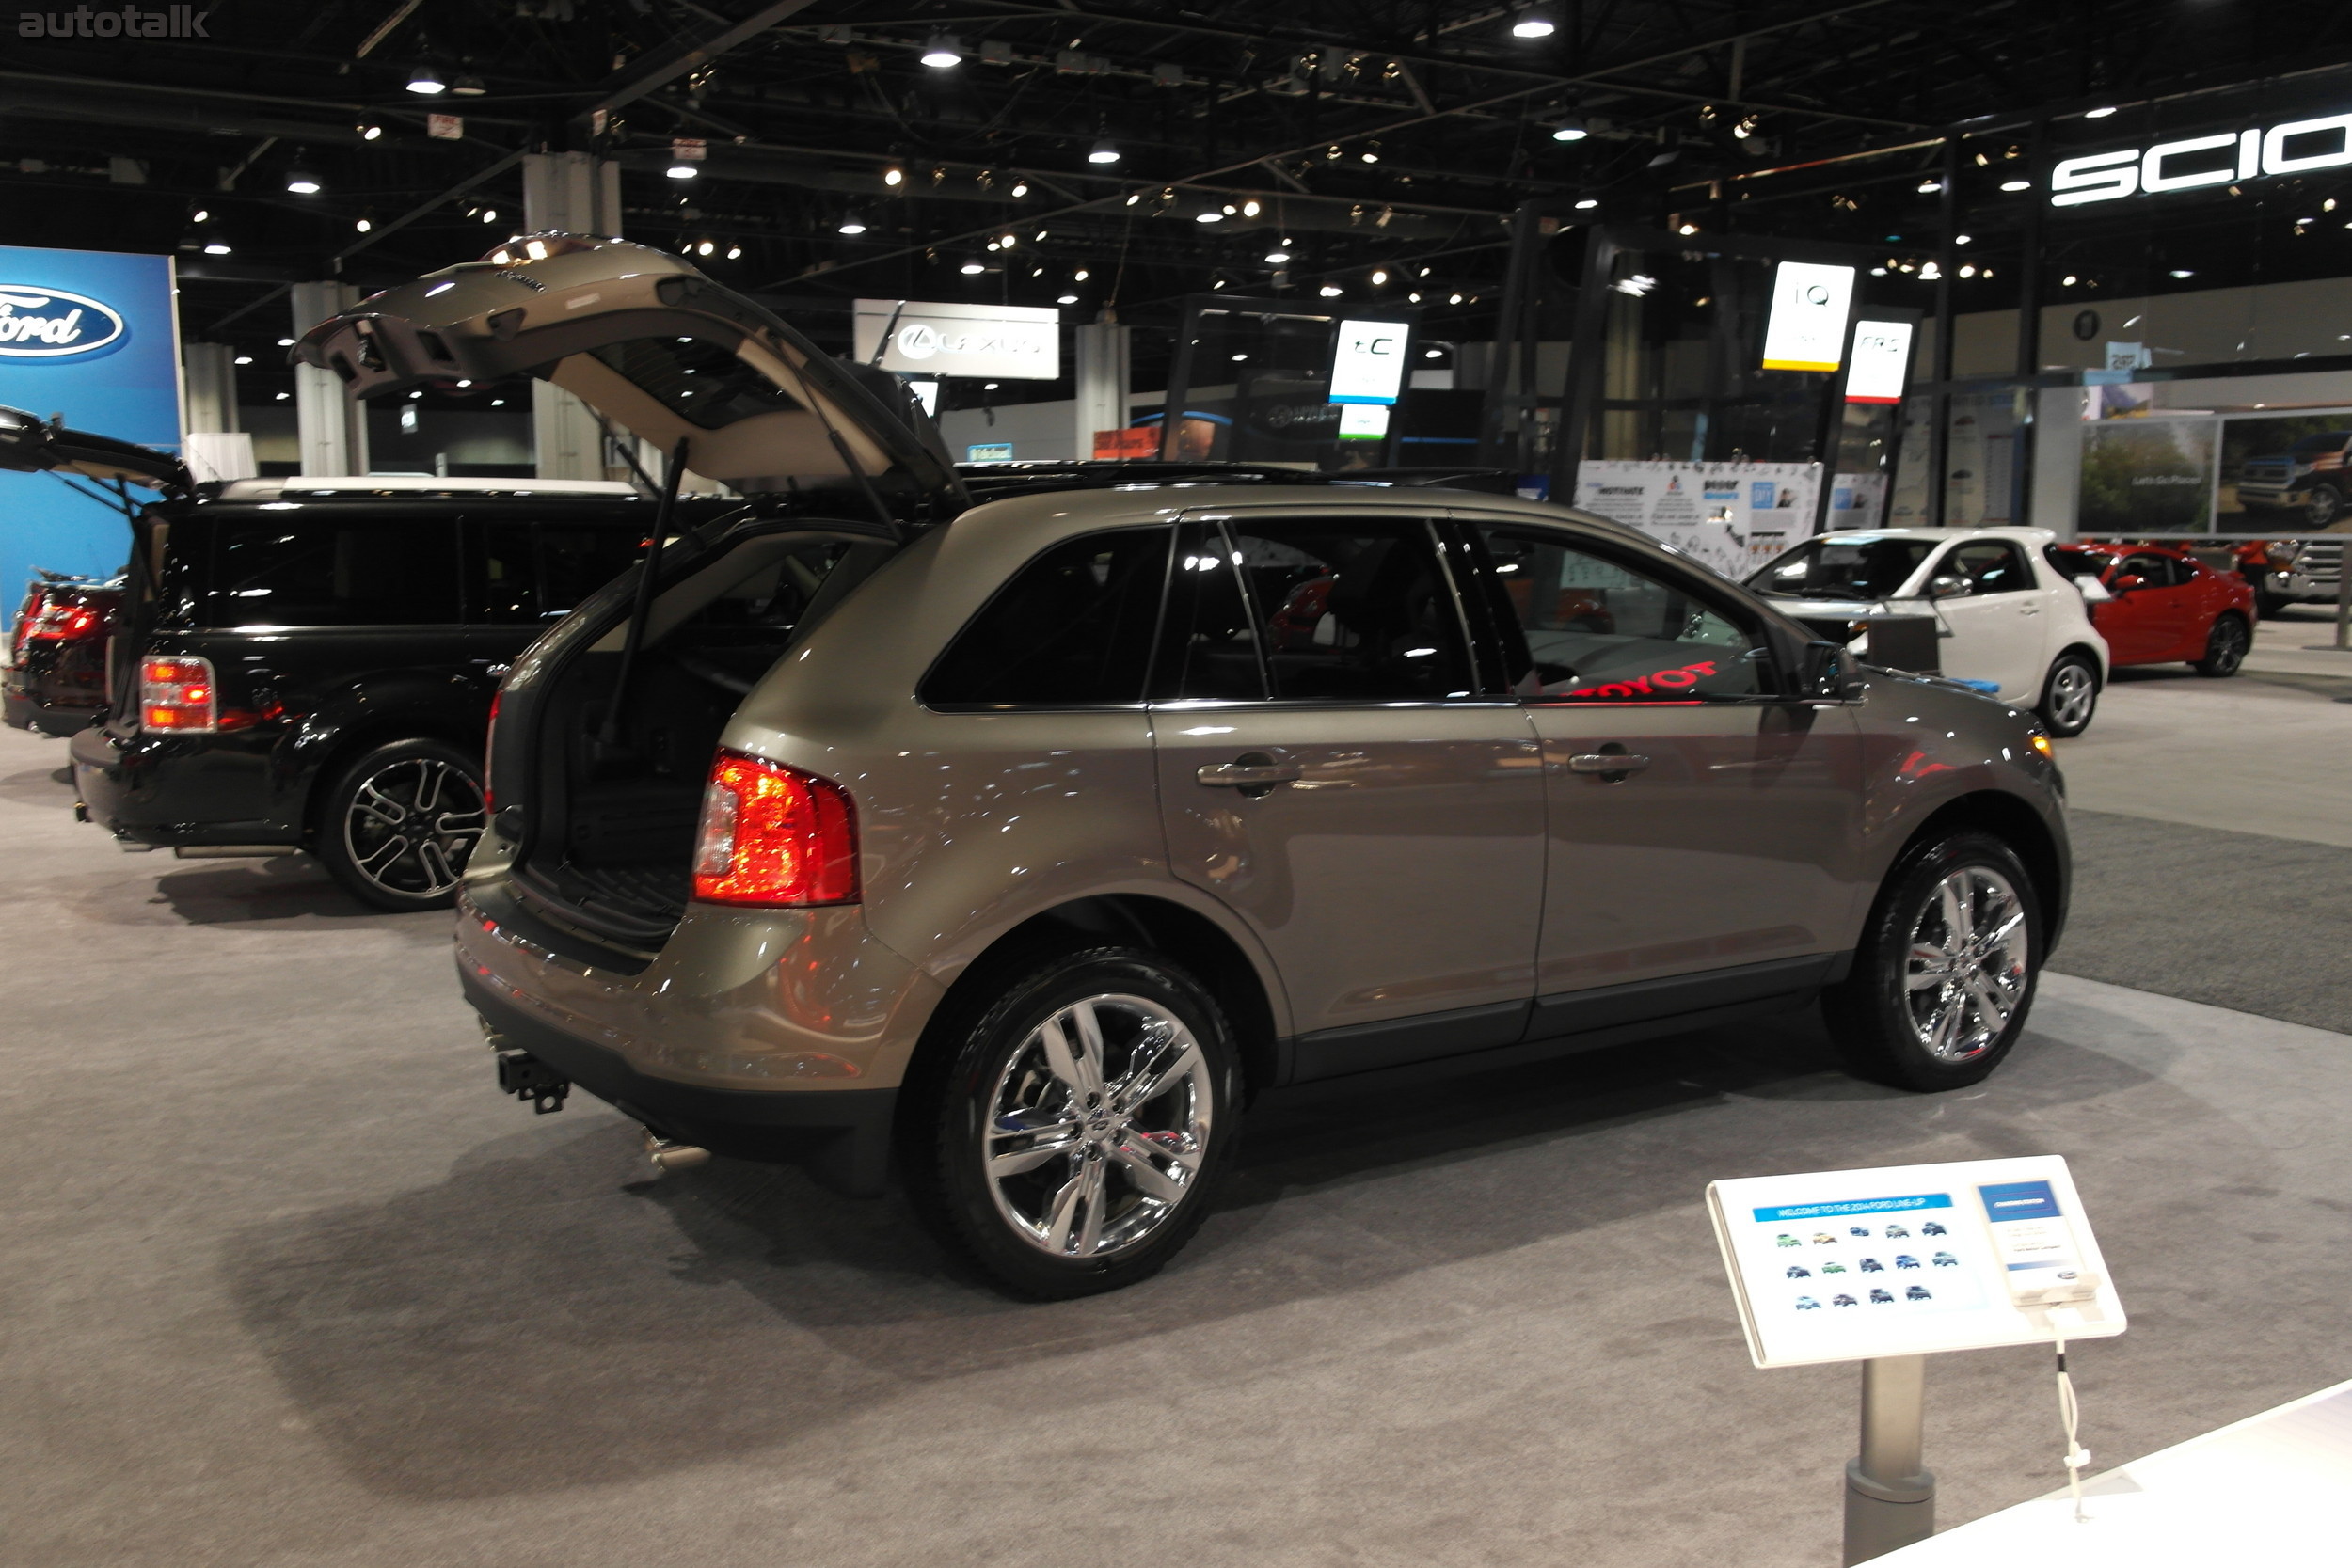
2051 808 2352 1032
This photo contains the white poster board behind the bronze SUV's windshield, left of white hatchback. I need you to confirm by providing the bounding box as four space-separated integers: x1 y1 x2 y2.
1576 458 1820 580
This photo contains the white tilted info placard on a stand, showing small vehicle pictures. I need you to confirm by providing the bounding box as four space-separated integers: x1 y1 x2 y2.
1708 1154 2124 1366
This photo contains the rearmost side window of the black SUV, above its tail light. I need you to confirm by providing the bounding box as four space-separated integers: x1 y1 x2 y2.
205 521 459 626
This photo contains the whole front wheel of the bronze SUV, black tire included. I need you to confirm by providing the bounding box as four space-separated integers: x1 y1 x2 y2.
1820 830 2042 1093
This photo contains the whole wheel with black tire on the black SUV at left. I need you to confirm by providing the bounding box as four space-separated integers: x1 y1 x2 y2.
310 740 487 912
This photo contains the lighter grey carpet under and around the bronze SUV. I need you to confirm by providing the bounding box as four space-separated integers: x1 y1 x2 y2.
0 734 2352 1568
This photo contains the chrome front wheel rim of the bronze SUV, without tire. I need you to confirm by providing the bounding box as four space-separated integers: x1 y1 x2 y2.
1903 865 2032 1063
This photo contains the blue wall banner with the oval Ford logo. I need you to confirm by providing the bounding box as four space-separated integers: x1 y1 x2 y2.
0 245 182 613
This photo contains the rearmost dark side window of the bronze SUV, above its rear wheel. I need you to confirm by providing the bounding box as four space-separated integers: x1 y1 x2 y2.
917 529 1174 707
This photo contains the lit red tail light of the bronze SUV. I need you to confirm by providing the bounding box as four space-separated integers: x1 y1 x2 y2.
694 752 859 905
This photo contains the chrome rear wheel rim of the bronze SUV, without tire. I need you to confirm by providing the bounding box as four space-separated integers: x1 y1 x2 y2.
981 994 1214 1258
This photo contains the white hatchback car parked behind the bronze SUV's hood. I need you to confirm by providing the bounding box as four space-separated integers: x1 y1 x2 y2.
1748 529 2107 736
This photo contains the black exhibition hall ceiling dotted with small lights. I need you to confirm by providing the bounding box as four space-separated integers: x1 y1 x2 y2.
0 0 2352 350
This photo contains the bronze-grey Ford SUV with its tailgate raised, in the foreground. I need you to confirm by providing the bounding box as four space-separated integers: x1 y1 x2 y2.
296 235 2068 1298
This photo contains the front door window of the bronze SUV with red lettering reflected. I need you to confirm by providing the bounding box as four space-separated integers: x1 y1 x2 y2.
1480 527 1772 703
